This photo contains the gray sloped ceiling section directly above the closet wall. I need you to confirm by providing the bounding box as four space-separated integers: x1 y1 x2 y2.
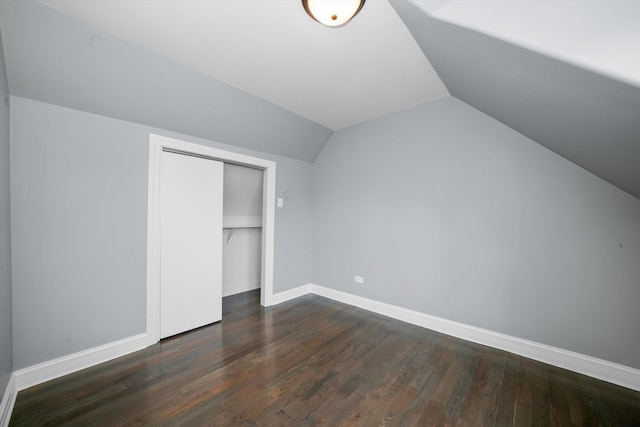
0 0 333 161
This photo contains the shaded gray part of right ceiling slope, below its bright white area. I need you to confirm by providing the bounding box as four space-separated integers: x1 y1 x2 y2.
391 0 640 198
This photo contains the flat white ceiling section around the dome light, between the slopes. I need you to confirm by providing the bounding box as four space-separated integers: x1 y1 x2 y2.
40 0 449 130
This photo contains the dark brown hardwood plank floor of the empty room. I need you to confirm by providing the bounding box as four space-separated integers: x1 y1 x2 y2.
10 292 640 426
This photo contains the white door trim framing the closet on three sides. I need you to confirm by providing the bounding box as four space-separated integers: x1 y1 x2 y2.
147 134 276 345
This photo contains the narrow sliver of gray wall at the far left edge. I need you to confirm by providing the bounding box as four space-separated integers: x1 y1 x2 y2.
0 31 13 400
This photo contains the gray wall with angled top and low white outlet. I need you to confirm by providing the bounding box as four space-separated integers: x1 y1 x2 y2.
312 98 640 368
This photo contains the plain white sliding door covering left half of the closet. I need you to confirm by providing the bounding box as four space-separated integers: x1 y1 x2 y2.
160 151 223 338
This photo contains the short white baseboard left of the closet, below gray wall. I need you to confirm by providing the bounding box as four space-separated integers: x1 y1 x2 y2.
14 333 149 391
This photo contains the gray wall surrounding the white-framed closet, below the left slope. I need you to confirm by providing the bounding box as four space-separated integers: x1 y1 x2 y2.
11 97 312 369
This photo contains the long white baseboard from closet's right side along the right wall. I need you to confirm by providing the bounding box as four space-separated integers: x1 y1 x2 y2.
274 284 640 391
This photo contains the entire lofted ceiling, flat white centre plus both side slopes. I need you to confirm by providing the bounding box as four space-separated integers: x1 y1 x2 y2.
0 0 640 198
